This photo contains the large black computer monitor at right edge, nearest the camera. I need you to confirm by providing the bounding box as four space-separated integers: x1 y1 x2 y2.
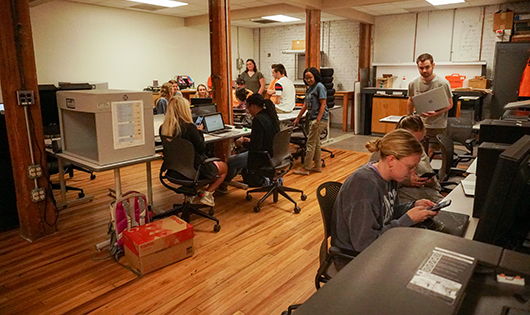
473 135 530 253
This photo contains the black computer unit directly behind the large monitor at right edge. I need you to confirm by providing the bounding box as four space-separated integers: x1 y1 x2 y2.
473 142 510 218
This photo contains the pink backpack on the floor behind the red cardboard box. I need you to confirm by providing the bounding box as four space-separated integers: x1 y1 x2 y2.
109 191 150 260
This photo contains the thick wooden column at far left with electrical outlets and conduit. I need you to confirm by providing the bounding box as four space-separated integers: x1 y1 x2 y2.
0 0 57 241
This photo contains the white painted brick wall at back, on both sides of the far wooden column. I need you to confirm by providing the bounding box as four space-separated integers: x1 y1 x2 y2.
254 20 359 91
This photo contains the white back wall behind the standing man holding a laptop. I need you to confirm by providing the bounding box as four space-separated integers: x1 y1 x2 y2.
374 2 530 79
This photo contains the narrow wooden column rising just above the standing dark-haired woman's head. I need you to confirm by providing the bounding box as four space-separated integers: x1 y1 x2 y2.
305 9 321 71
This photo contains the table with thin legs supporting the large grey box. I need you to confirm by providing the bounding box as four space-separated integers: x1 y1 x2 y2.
55 153 162 208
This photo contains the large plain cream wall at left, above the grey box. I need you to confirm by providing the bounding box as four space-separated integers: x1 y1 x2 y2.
30 1 253 90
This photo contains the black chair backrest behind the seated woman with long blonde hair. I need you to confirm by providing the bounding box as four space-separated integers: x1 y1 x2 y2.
162 137 197 180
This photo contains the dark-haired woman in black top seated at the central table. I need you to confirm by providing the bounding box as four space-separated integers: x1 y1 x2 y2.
223 94 280 188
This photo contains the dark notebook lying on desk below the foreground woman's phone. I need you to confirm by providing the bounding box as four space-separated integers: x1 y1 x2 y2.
415 210 469 236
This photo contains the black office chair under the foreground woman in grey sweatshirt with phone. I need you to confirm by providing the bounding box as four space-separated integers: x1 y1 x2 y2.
282 182 355 315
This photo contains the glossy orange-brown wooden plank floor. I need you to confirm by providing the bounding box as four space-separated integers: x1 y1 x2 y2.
0 150 368 315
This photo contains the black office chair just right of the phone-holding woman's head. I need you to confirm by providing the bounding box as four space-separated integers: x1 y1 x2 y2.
436 134 475 192
